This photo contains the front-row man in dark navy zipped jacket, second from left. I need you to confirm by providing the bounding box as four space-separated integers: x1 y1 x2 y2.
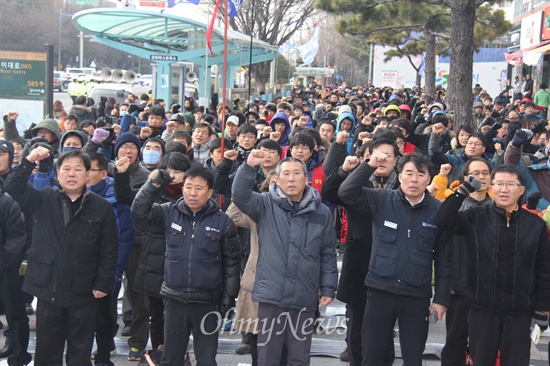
132 167 241 366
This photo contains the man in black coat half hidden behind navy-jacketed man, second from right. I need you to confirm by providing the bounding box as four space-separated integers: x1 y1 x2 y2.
321 138 399 366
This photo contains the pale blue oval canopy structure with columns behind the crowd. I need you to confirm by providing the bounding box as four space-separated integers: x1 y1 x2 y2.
72 8 278 101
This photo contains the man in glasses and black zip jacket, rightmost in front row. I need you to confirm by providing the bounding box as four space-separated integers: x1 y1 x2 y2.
435 164 550 366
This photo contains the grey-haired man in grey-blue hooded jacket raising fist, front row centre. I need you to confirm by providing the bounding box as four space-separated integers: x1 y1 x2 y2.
232 150 338 366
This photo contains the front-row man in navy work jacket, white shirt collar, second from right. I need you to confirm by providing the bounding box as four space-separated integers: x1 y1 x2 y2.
338 149 451 366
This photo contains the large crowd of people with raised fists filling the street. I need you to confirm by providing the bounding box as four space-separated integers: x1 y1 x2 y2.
0 80 550 366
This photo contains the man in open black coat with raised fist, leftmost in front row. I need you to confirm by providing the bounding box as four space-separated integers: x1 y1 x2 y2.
6 146 118 366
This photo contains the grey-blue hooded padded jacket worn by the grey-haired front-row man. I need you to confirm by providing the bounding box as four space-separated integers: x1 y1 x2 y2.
232 164 338 311
